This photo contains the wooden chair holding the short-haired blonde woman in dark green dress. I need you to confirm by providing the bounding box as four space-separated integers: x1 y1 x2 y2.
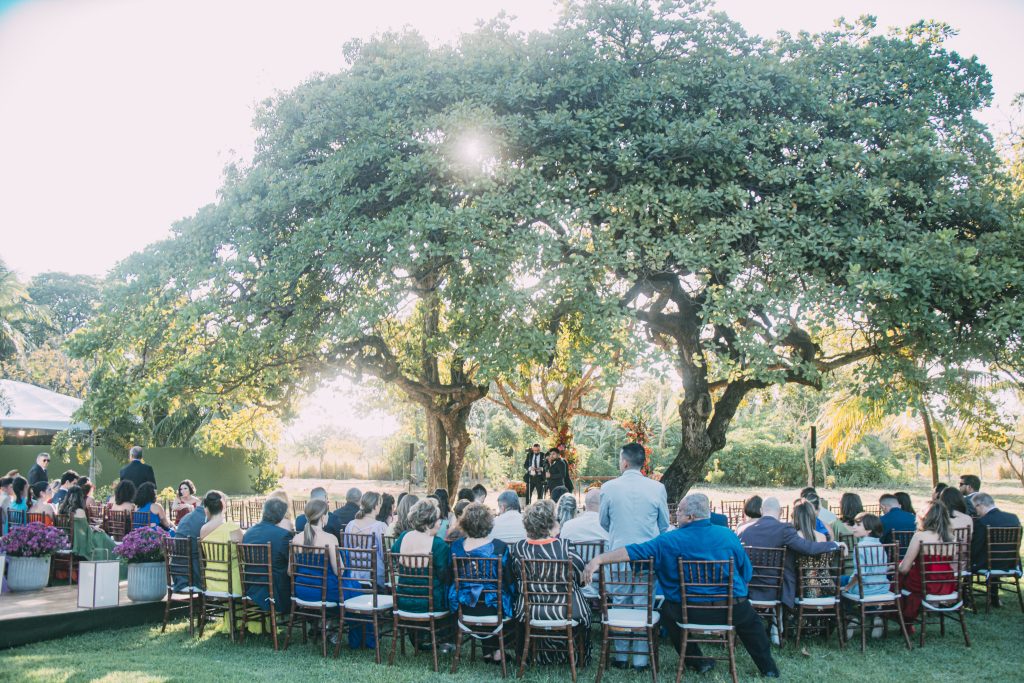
388 553 451 673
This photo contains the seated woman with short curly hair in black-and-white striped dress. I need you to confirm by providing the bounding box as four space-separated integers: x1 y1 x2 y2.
509 500 591 667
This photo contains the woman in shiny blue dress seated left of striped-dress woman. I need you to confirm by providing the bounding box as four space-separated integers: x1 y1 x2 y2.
449 503 513 663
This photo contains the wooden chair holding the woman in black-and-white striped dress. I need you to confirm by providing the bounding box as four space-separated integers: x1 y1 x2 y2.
519 558 580 683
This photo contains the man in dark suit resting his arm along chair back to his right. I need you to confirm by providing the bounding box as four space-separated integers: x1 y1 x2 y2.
739 498 846 609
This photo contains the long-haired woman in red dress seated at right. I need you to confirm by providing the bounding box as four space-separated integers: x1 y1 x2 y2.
899 503 956 623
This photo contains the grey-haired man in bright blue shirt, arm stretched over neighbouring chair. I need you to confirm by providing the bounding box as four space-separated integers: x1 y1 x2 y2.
584 494 778 678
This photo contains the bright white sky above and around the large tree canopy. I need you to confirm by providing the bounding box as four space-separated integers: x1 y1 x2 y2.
0 0 1024 432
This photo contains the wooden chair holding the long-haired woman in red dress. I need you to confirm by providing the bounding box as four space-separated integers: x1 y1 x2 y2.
916 542 971 647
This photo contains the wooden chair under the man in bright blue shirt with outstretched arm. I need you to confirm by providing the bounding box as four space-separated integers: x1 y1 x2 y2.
676 557 738 683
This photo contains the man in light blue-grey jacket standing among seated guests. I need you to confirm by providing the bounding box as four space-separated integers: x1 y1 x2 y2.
599 443 669 669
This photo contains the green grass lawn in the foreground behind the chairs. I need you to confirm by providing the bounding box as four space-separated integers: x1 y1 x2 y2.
8 599 1024 683
